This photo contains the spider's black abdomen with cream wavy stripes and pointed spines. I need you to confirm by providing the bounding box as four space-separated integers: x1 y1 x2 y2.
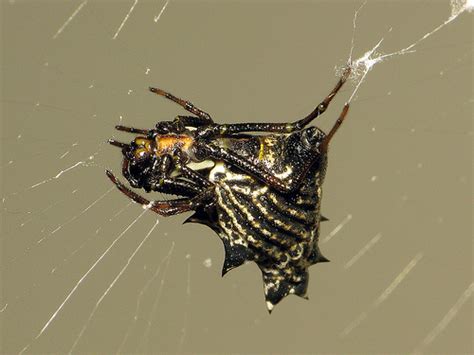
209 153 326 310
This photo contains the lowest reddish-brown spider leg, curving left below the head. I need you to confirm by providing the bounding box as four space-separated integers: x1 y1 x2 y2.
106 170 212 217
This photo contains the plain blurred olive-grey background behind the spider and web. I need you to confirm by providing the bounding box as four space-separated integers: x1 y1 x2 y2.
0 0 474 354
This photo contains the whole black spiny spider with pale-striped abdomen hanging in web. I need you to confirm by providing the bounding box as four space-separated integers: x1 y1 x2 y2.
106 67 350 312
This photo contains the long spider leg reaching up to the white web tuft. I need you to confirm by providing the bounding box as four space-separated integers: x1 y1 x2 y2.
201 67 351 138
